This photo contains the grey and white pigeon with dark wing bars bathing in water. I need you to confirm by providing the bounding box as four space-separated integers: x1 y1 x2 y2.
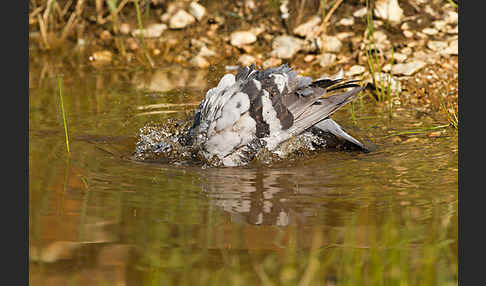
190 62 367 166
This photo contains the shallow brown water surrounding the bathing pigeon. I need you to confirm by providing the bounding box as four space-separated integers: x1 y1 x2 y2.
29 67 458 285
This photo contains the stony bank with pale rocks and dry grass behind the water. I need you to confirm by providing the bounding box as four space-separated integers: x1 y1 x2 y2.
29 0 458 127
